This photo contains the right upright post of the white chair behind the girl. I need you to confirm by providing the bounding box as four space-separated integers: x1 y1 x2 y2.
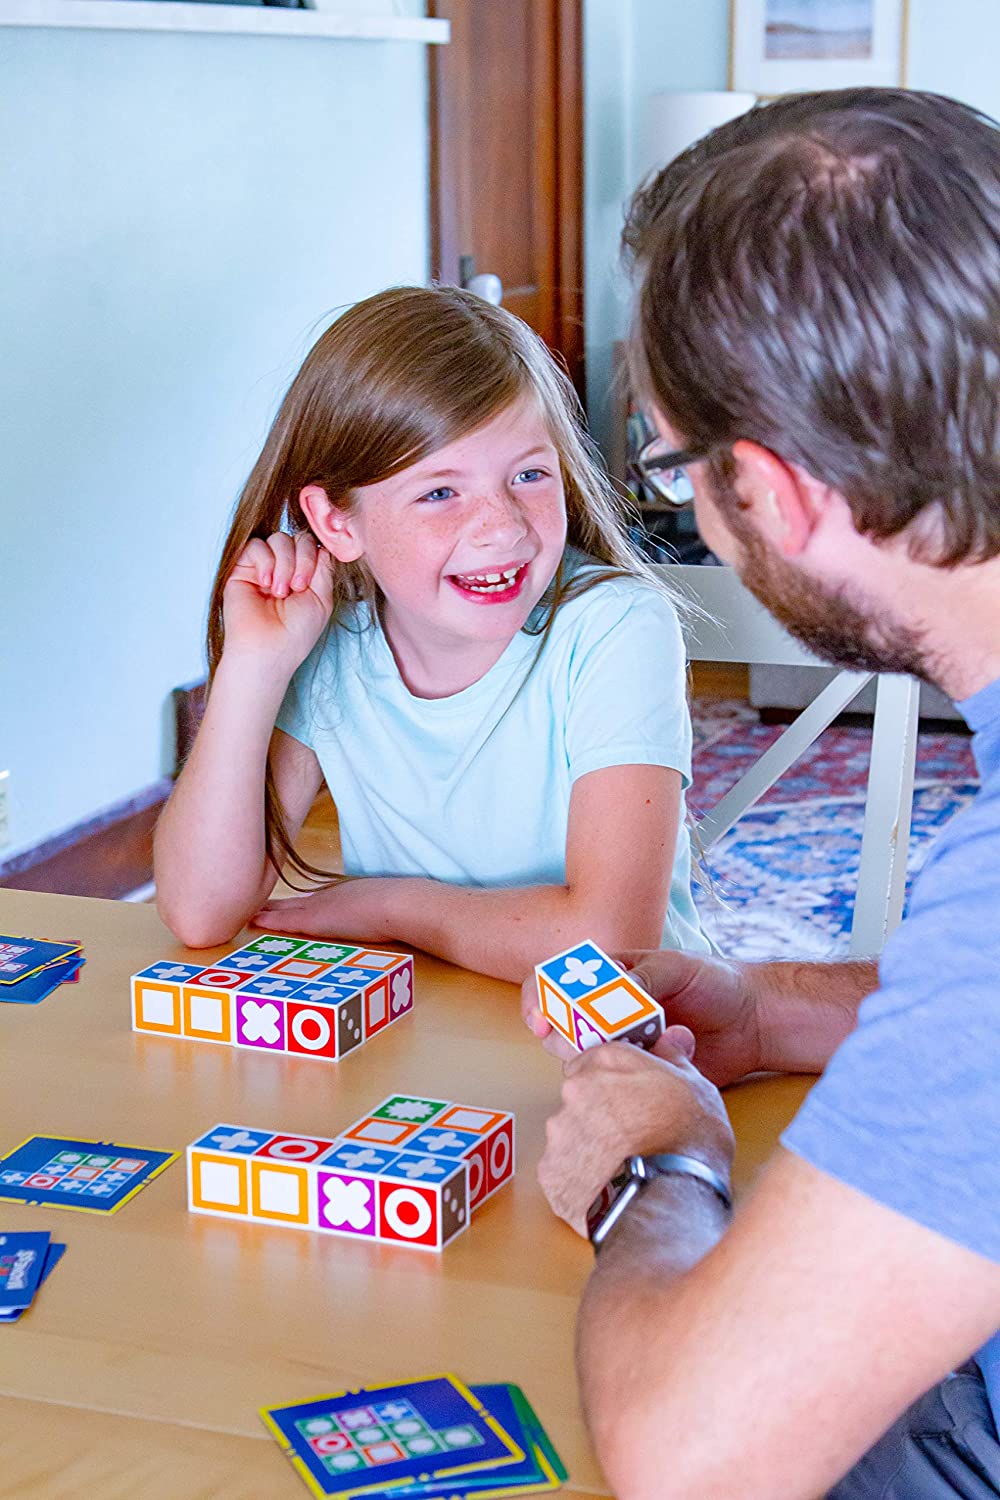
850 675 921 957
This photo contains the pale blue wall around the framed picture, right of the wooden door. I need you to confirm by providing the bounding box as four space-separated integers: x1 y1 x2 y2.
583 0 1000 452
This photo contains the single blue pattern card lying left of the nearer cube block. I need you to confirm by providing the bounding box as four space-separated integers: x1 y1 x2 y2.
0 1136 180 1214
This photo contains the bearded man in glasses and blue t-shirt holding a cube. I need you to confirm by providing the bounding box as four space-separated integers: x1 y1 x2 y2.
525 90 1000 1500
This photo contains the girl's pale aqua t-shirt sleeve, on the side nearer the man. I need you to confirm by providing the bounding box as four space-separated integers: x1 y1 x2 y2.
565 585 691 788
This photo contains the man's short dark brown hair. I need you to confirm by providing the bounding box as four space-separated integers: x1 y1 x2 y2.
624 89 1000 566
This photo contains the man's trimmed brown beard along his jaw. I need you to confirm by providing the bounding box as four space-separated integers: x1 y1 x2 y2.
715 479 934 683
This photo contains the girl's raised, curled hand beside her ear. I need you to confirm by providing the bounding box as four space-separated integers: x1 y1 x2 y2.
222 531 334 674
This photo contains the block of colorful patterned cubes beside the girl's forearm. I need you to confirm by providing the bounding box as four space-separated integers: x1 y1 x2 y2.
132 936 414 1062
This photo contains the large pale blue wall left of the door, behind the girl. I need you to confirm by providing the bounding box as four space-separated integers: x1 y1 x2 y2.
0 23 427 861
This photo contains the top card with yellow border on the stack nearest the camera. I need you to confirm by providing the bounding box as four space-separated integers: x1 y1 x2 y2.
261 1376 525 1500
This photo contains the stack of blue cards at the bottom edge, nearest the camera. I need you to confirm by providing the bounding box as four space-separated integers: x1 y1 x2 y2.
261 1376 567 1500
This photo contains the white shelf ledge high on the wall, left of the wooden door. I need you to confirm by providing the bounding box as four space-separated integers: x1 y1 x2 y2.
0 0 450 42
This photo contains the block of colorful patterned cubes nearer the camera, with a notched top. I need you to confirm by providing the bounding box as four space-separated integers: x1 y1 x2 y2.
187 1095 514 1250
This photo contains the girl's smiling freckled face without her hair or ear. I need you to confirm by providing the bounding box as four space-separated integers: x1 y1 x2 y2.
352 399 567 644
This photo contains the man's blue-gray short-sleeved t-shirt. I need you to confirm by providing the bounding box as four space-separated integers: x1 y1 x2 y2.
781 680 1000 1427
